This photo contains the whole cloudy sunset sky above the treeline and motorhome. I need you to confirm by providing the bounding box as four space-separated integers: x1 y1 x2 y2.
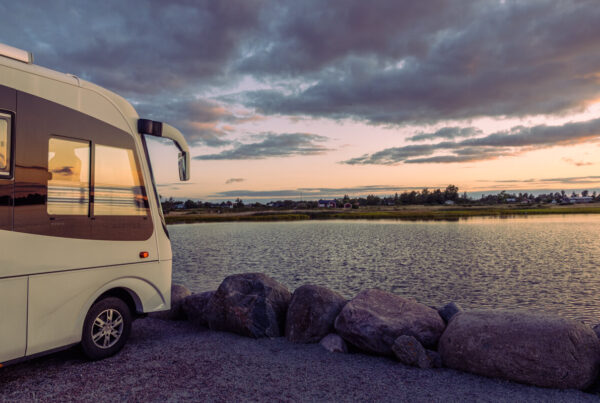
0 0 600 200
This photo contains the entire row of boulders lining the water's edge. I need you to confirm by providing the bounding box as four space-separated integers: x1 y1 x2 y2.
155 273 600 390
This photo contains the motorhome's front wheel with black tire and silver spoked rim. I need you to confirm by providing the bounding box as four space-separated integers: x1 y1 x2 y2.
81 297 132 360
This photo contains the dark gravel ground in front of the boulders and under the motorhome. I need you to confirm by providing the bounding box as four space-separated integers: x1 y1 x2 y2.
0 319 598 402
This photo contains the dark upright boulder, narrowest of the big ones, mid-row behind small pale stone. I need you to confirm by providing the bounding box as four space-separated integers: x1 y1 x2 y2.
285 284 346 343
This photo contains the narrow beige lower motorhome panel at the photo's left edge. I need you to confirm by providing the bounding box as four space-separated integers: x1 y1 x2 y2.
0 277 27 362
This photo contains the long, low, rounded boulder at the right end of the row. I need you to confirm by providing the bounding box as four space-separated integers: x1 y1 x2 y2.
439 310 600 389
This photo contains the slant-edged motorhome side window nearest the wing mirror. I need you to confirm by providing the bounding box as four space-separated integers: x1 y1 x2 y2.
94 145 148 216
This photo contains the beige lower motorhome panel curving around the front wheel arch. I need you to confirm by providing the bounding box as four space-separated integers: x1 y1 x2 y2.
27 261 171 355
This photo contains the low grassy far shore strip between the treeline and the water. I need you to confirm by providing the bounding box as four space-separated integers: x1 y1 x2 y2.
165 203 600 224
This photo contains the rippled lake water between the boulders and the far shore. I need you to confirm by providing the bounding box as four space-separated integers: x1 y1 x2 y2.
169 215 600 324
